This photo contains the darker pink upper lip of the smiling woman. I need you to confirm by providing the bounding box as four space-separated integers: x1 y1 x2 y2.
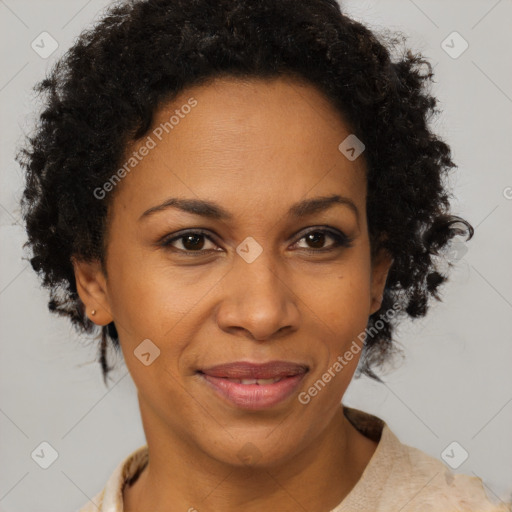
200 361 308 379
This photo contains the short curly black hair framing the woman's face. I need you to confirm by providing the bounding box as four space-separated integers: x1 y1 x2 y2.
16 0 473 383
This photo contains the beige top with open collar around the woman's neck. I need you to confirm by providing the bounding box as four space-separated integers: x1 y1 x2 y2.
78 406 512 512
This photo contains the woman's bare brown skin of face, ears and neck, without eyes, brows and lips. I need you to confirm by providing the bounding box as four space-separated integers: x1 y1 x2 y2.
74 77 392 512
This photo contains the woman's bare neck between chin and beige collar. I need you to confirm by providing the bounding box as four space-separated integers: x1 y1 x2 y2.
124 407 377 512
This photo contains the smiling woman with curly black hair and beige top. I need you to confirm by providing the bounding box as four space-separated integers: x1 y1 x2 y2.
19 0 506 512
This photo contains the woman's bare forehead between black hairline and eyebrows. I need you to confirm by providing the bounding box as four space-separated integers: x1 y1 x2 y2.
110 77 366 222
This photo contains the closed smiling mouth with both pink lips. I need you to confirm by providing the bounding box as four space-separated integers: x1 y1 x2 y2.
197 361 309 410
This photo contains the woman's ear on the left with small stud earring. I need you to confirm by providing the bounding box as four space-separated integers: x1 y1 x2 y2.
71 258 113 325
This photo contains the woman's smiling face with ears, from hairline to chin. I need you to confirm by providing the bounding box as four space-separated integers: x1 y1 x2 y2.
75 78 390 465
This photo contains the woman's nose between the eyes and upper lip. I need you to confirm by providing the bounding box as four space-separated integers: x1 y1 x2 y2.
217 250 300 341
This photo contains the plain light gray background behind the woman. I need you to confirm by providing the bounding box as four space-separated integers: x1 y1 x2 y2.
0 0 512 512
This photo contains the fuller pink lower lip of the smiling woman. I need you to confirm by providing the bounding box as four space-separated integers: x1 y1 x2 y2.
200 373 305 410
